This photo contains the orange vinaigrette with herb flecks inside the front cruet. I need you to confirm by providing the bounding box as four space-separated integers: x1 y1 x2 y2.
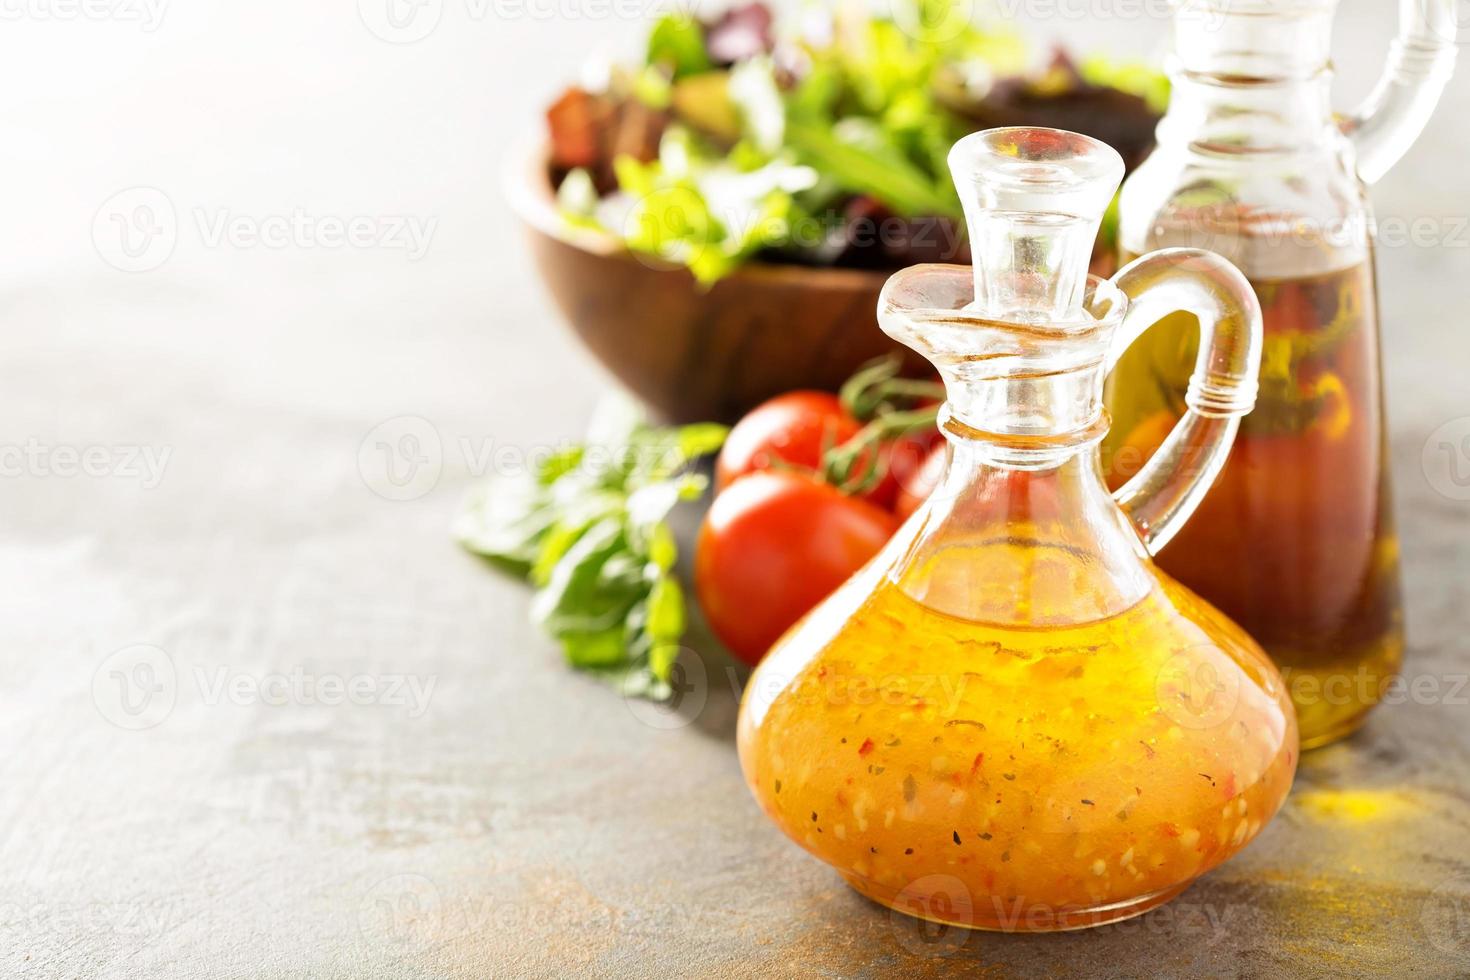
739 537 1295 930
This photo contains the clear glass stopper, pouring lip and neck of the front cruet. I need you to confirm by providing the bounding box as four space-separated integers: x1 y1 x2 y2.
878 126 1127 466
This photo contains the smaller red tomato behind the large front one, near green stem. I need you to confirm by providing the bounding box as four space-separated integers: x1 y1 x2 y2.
714 391 863 489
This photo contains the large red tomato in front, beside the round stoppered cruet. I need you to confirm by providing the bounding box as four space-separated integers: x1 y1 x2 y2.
694 470 898 664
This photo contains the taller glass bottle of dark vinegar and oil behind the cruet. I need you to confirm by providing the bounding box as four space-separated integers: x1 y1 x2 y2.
1103 0 1455 748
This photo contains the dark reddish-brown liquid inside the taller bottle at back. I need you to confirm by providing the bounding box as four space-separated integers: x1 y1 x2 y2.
1103 260 1404 748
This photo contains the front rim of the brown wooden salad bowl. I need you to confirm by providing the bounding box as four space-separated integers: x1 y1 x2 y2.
501 134 892 292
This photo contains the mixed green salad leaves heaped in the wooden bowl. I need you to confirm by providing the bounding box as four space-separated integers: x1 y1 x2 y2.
562 0 1169 285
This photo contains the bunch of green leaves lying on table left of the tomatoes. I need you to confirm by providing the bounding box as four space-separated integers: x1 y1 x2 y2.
454 403 726 699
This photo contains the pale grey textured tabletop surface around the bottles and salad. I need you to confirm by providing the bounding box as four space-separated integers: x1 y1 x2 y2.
0 0 1470 980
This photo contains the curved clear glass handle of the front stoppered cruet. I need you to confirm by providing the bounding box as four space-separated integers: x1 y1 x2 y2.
1107 248 1261 554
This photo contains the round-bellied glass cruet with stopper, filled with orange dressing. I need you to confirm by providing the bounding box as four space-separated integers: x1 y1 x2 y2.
738 128 1297 930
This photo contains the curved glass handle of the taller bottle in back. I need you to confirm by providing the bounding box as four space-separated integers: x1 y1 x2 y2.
1342 0 1458 184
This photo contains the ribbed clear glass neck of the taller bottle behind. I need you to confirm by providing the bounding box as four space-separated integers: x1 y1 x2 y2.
1158 0 1339 156
